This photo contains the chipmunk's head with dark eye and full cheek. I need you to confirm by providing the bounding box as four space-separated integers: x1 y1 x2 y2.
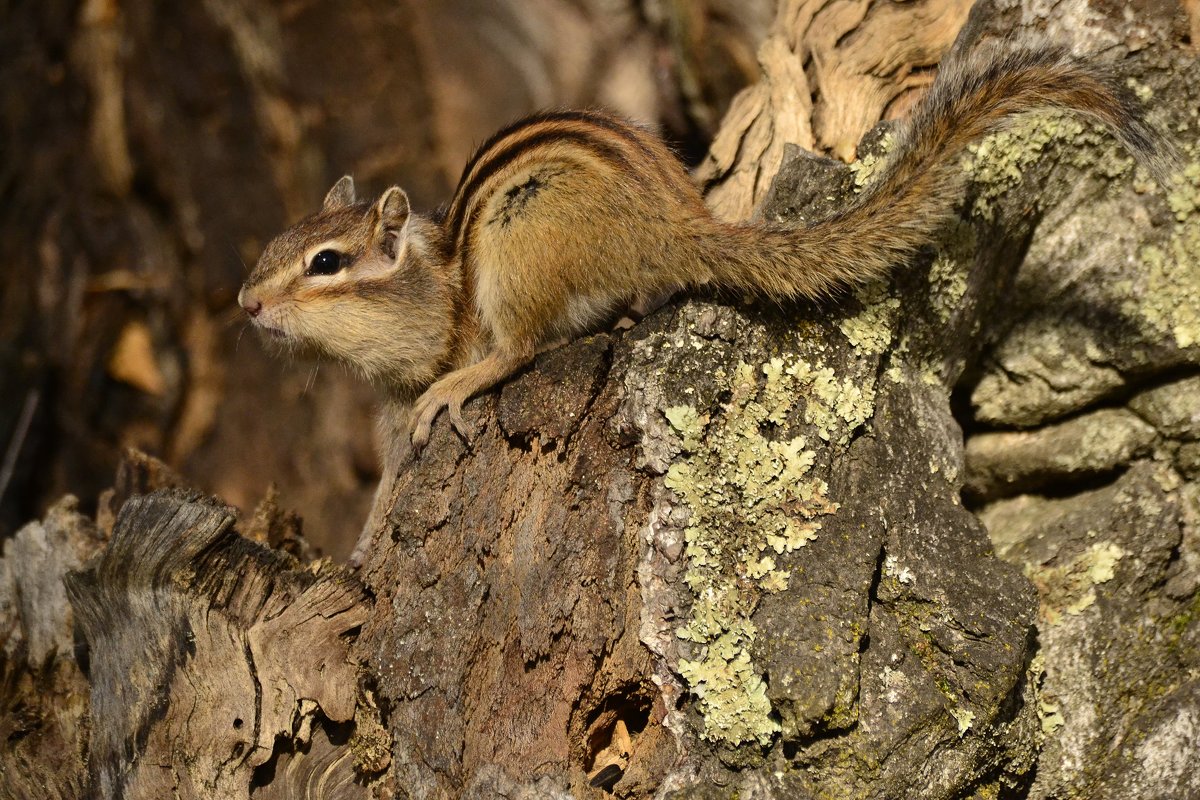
238 176 451 389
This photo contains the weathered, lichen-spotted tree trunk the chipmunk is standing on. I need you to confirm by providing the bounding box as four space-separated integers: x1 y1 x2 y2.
0 0 1200 800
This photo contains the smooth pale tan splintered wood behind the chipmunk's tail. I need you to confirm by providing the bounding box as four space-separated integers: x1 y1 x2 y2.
697 0 971 219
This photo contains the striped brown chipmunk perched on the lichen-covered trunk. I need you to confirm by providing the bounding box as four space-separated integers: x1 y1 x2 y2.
238 48 1163 451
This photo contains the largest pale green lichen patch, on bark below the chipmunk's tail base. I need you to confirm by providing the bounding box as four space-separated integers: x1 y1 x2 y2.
665 359 844 745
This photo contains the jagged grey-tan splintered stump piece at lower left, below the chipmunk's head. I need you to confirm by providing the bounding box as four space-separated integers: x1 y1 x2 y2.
66 489 370 799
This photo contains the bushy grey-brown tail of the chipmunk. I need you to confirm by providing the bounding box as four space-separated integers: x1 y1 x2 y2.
704 48 1172 299
